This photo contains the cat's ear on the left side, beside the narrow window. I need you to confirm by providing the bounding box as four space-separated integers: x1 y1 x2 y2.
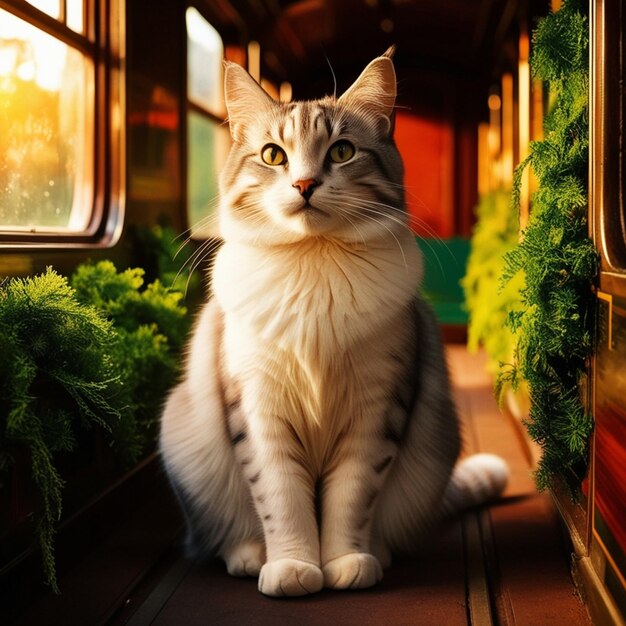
224 61 275 141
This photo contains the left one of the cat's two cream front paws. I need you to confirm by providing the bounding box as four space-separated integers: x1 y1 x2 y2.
259 559 324 597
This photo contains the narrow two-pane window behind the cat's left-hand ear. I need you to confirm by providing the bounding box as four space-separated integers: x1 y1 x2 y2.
186 7 230 237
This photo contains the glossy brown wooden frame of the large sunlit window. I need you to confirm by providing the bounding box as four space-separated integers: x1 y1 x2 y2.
0 0 126 249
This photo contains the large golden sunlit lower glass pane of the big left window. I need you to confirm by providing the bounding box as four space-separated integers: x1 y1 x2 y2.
0 9 94 232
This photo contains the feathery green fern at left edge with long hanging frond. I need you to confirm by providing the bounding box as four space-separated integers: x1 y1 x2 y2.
0 268 126 589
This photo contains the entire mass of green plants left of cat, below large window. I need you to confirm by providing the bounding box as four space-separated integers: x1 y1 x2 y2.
0 261 189 591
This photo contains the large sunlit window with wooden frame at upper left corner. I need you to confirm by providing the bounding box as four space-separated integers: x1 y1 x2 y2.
0 0 123 246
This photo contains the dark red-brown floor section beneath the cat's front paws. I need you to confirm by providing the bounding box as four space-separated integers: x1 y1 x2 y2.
141 522 467 626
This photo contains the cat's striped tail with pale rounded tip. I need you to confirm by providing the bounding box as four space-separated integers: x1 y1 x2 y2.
443 454 510 515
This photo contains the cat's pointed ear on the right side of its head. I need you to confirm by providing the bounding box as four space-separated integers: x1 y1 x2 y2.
338 46 396 134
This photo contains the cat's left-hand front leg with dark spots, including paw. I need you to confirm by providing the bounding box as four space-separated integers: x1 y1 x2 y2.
244 414 324 596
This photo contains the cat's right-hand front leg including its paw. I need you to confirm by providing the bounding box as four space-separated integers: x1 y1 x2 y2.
321 406 397 589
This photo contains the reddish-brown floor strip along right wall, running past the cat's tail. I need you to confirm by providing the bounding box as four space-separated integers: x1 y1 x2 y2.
448 349 590 626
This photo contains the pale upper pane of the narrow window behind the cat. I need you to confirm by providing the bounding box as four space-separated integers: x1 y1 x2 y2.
187 8 224 117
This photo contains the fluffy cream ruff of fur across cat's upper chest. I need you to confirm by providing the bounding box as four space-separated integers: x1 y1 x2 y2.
213 231 422 360
